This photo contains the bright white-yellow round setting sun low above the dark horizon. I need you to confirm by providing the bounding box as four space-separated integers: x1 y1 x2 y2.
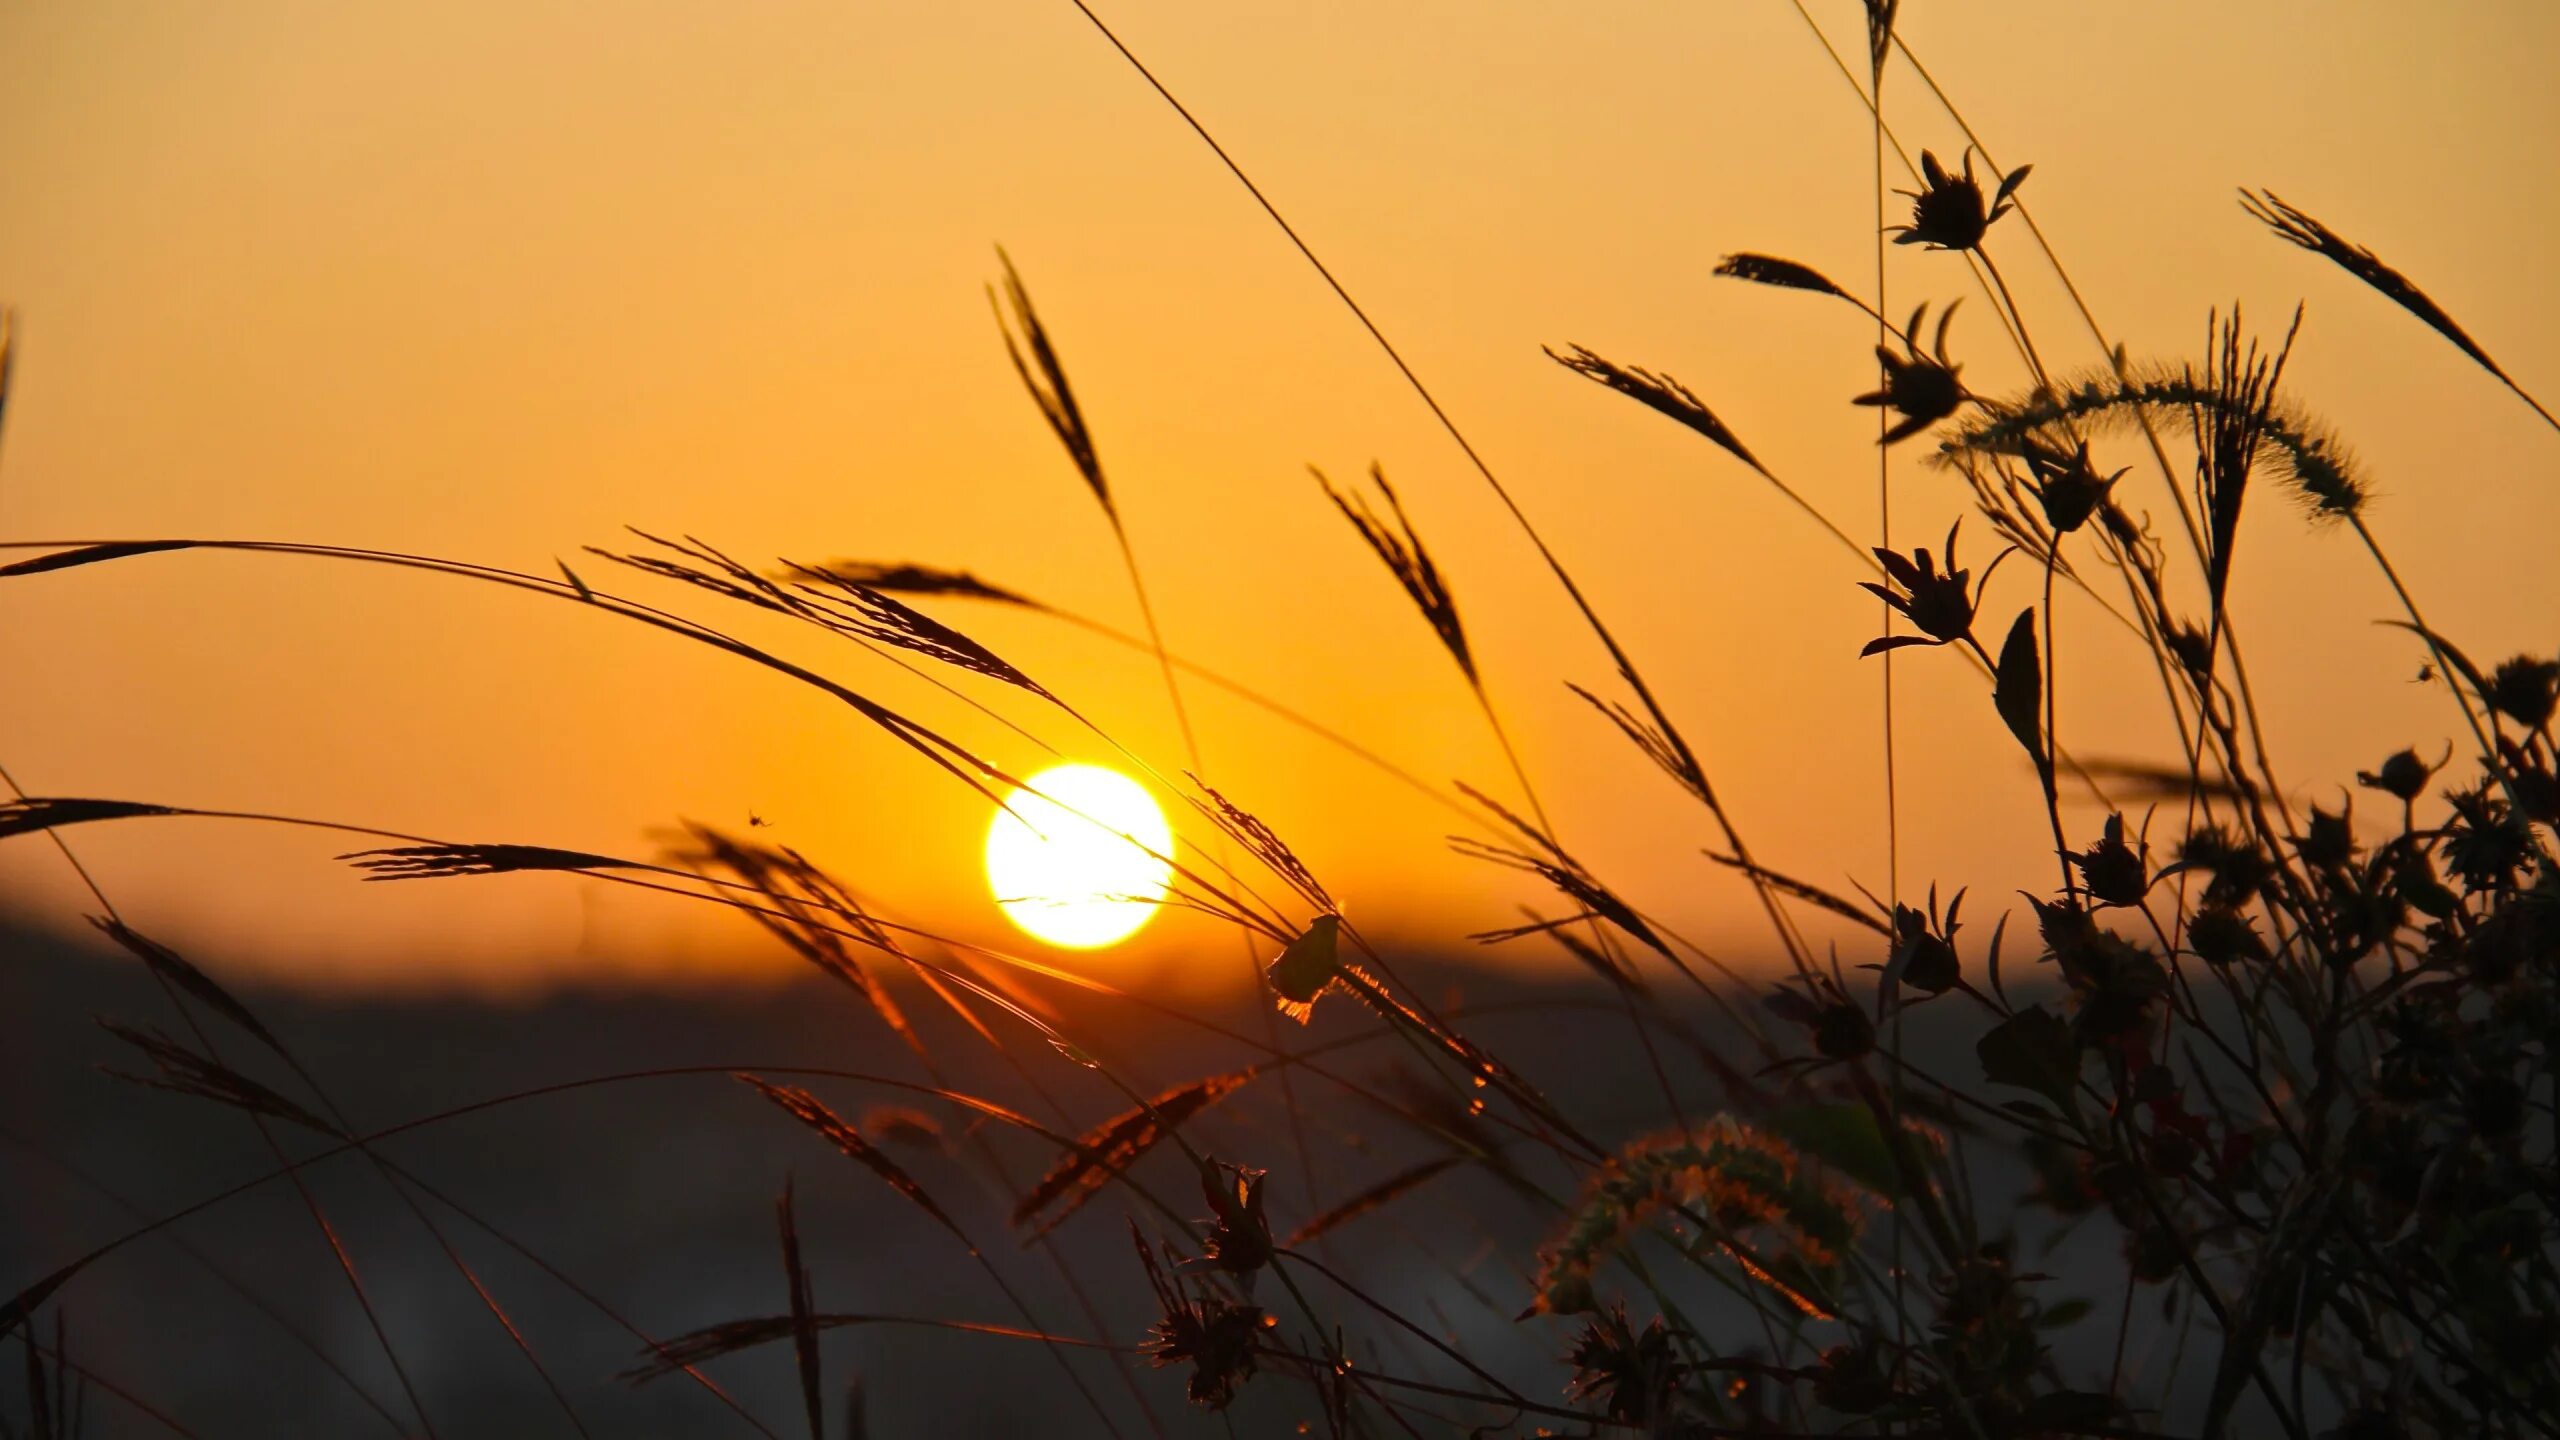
986 766 1172 951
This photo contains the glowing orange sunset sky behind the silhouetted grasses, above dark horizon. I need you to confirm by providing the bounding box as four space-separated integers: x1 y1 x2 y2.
0 0 2560 986
